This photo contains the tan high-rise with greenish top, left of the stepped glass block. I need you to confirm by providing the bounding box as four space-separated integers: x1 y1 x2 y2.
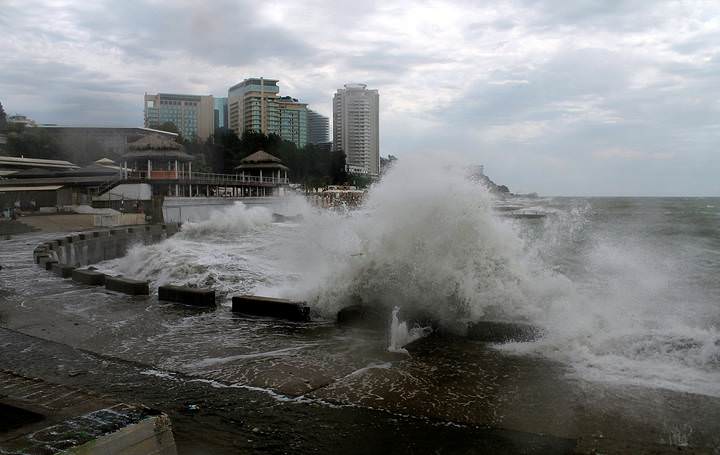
228 77 280 136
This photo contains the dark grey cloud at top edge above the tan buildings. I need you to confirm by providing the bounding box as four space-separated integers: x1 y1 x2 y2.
73 0 313 66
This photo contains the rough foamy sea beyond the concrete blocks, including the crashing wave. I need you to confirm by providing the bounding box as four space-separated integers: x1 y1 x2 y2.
101 158 720 396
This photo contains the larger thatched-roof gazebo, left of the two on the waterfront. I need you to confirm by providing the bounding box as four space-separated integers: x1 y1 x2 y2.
122 135 195 180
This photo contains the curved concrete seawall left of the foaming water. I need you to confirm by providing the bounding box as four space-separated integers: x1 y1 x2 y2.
33 223 180 267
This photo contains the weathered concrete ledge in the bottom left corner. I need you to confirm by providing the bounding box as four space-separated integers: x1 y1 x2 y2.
0 370 177 455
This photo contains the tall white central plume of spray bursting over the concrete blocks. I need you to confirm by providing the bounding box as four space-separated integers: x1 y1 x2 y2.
279 157 567 323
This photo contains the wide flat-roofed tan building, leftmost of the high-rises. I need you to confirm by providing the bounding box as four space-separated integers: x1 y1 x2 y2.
145 93 215 140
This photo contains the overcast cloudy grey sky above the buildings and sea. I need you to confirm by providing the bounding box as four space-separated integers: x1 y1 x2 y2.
0 0 720 196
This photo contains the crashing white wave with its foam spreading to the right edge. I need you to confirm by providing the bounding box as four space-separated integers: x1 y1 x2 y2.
276 157 720 396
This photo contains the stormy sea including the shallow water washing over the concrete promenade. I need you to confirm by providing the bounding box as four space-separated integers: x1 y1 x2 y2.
0 156 720 448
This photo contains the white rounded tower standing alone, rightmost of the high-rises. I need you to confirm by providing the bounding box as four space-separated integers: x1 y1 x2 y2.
333 84 380 177
